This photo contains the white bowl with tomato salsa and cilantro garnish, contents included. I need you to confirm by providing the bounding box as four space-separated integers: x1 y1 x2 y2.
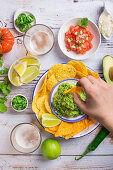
58 18 101 60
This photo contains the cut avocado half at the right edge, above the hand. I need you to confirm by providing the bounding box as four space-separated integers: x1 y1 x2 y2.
103 55 113 85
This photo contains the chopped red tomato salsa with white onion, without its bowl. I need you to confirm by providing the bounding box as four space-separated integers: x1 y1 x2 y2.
65 25 94 54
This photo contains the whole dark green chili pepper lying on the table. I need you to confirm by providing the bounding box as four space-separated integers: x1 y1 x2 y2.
75 127 110 160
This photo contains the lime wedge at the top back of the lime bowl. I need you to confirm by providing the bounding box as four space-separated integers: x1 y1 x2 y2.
19 58 40 66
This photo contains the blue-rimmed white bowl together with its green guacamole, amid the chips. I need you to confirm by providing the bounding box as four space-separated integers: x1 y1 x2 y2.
50 78 86 122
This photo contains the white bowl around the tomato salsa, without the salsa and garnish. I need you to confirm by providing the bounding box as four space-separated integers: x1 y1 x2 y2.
58 18 101 60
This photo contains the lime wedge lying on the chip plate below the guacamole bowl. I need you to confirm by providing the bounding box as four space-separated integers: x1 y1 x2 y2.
42 113 61 127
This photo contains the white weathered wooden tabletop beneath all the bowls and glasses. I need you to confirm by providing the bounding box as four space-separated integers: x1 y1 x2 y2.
0 0 113 170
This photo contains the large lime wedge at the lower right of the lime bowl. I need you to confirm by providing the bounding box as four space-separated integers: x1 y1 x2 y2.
20 66 40 83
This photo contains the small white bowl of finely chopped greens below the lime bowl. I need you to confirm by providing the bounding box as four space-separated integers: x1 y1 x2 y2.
11 94 28 112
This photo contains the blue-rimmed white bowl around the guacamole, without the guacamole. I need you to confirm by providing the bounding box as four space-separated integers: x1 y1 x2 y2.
50 78 86 122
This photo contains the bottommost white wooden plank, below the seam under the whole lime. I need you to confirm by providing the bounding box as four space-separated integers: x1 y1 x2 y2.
0 155 113 170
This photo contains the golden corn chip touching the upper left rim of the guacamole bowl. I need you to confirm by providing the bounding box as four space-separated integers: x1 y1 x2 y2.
47 74 58 92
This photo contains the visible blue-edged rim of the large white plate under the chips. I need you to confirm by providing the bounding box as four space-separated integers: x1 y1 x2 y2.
32 68 100 139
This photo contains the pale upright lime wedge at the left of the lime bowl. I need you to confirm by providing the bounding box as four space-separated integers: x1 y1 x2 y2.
14 62 27 76
